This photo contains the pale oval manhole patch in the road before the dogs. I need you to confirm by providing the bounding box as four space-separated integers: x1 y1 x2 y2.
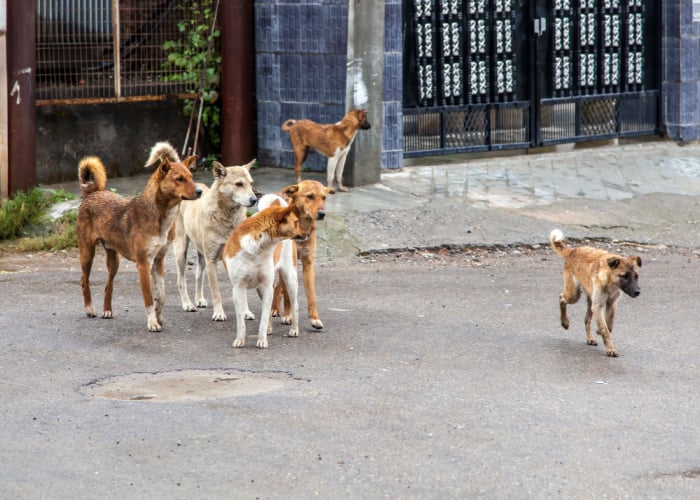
81 369 291 402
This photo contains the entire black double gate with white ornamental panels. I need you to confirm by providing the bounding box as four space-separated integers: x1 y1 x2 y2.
403 0 661 157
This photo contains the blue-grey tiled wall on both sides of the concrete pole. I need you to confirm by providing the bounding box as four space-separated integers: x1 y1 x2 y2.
255 0 402 170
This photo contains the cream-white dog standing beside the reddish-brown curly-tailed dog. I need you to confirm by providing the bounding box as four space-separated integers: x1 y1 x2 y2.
173 160 258 321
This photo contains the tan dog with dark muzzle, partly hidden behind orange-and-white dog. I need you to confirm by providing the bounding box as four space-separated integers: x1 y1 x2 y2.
272 180 335 330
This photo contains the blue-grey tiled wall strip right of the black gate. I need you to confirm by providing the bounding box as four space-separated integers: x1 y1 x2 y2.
661 0 700 141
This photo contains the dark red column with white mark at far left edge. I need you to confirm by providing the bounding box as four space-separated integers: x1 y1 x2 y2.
6 0 36 196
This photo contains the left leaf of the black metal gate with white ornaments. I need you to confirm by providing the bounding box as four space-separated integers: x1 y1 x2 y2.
403 0 531 156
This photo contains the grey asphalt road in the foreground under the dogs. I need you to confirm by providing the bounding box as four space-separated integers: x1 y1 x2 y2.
0 247 700 499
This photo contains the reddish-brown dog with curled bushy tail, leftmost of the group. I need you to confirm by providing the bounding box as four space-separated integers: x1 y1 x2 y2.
76 142 202 332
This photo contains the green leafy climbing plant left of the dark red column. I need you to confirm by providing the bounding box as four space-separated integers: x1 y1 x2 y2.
163 0 221 147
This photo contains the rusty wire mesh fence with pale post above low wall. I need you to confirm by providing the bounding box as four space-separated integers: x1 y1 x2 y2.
34 0 218 105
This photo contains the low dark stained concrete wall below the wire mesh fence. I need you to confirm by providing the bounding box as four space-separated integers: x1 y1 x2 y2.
36 99 189 183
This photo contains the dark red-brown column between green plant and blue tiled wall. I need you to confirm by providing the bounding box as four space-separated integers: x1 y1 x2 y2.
221 0 258 165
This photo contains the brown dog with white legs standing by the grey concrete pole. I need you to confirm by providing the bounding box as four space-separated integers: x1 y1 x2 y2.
282 109 371 191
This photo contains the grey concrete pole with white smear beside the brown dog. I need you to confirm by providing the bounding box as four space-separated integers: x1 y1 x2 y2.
343 0 385 186
